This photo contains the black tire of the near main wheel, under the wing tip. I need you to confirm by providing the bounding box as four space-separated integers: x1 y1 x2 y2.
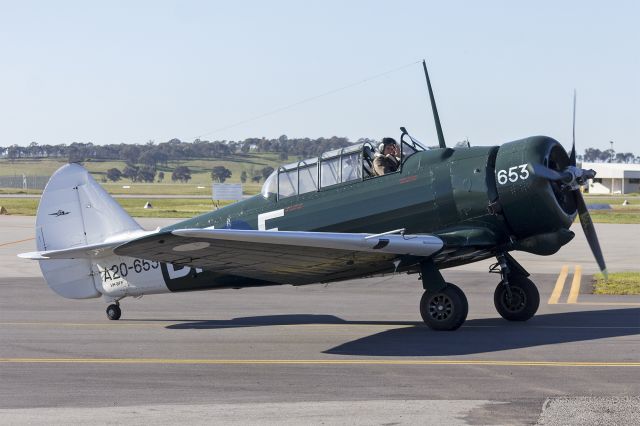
420 283 469 331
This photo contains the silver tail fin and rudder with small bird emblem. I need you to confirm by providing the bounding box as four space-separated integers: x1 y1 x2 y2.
36 164 142 299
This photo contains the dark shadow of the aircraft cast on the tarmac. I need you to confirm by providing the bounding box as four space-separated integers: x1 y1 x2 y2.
161 308 640 356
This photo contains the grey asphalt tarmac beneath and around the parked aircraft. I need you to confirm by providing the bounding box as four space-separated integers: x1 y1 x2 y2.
0 216 640 424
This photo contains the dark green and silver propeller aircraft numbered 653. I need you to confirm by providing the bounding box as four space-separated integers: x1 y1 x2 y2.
21 63 606 330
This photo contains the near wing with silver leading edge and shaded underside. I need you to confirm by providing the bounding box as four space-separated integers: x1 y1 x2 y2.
113 229 443 284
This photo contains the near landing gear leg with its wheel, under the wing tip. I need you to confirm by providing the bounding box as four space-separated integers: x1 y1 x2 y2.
420 260 469 330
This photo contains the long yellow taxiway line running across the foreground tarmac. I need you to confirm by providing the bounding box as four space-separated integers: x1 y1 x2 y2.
0 358 640 367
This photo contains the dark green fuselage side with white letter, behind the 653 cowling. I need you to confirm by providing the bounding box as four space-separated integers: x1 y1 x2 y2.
169 147 505 240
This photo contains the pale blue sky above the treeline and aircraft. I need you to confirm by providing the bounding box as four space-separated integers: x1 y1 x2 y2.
0 0 640 154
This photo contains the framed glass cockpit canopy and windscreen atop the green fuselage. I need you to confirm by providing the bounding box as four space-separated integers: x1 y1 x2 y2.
261 141 425 199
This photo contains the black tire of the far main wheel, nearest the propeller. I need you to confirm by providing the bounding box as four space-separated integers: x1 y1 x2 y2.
493 277 540 321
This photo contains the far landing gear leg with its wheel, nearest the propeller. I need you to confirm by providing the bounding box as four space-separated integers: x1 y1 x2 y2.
490 253 540 321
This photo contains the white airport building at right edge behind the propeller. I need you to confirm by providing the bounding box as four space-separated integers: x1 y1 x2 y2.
582 163 640 194
